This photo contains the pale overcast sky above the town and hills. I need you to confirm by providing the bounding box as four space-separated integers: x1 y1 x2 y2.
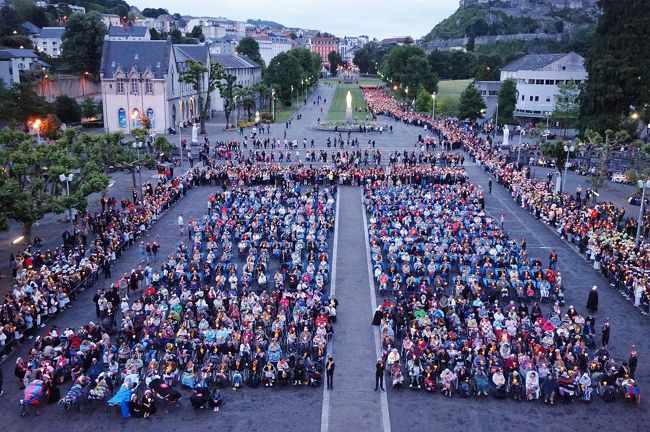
129 0 458 39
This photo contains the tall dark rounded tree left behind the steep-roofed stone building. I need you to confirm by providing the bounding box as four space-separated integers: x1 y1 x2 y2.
61 12 106 77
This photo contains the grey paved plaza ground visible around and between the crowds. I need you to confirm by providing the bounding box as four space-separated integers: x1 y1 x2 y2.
0 85 650 432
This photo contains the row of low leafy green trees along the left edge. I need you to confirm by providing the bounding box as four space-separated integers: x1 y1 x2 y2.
0 129 171 241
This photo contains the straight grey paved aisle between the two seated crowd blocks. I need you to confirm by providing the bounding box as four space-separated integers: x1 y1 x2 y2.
321 187 383 432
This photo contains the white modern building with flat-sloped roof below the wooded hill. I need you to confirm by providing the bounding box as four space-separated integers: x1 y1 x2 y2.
501 52 587 118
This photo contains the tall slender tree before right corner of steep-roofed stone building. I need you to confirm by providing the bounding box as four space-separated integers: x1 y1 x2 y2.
178 60 224 134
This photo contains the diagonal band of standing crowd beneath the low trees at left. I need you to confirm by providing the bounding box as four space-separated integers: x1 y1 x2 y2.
0 173 194 354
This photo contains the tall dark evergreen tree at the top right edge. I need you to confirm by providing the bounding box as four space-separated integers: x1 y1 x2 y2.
580 0 650 134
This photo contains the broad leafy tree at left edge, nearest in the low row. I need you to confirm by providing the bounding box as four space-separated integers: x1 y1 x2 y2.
0 130 109 242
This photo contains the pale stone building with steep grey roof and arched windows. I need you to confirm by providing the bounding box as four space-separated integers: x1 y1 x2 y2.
100 38 210 134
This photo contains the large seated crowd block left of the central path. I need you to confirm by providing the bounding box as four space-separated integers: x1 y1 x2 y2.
16 182 337 417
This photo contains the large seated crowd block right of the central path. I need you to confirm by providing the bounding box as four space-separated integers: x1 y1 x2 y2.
365 178 638 404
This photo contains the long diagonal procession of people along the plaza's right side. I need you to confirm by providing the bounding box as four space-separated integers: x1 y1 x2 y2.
364 89 650 313
